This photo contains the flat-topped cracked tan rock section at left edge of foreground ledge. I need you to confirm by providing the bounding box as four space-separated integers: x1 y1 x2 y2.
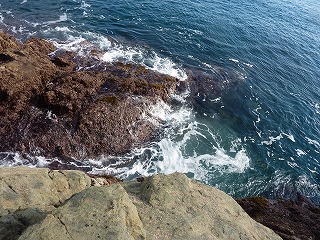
0 167 91 212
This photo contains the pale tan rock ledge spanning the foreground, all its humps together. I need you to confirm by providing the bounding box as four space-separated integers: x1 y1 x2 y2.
0 167 281 240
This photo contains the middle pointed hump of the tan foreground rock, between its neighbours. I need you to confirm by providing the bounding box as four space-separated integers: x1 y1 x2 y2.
19 184 145 240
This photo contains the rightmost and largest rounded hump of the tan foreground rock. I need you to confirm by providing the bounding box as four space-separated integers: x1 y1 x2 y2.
124 174 281 240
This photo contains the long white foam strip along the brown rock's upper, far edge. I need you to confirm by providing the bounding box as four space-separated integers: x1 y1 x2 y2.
47 26 187 80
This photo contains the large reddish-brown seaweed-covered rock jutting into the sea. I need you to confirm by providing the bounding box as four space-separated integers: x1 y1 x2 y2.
0 33 178 160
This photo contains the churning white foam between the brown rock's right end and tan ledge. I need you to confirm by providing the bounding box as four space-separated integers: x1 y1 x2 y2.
87 102 250 180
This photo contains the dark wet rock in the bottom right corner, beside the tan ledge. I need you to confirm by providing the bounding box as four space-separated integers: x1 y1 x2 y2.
237 195 320 240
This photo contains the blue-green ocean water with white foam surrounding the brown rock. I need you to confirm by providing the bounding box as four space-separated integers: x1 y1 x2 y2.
0 0 320 203
